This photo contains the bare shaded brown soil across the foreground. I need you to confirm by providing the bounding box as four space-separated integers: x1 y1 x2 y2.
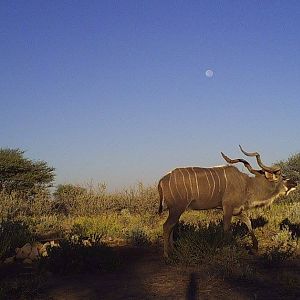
42 246 300 300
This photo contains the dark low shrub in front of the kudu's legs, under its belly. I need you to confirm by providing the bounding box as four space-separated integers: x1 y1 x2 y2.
171 222 255 279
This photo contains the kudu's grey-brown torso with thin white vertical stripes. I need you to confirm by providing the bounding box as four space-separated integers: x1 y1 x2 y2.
158 166 240 212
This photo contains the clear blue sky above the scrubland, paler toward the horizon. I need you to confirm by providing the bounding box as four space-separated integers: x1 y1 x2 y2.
0 0 300 189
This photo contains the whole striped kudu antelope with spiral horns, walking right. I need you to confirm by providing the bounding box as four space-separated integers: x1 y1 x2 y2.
158 146 296 257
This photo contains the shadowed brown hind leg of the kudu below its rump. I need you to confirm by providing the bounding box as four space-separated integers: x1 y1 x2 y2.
163 209 182 257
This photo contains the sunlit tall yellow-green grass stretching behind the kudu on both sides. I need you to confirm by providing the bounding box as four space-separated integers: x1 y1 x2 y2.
0 183 300 262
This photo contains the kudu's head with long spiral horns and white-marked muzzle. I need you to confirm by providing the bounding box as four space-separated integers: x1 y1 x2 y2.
221 145 297 195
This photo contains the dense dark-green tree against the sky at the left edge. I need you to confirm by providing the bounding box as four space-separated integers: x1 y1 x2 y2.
0 148 55 195
